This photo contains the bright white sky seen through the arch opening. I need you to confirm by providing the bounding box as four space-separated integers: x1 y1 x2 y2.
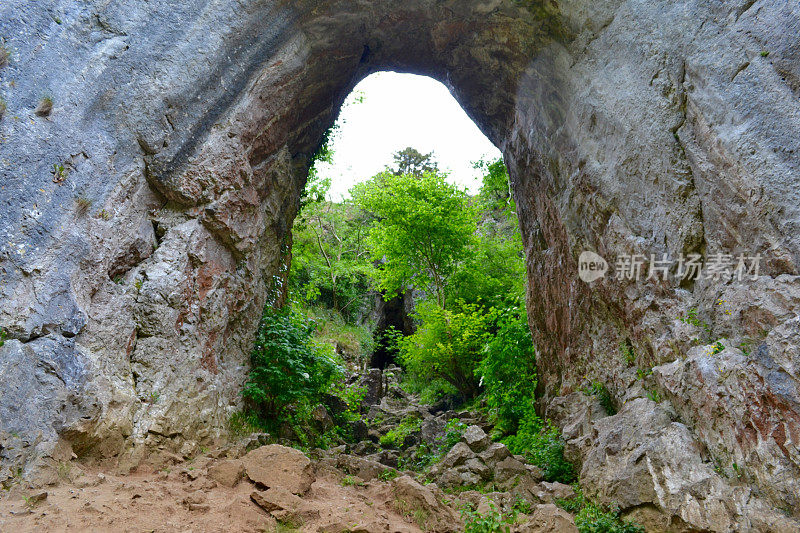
319 72 501 200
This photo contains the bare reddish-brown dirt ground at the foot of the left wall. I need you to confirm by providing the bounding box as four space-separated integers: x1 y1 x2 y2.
0 457 432 533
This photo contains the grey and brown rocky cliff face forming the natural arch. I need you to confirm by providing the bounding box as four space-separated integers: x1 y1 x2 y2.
0 0 800 531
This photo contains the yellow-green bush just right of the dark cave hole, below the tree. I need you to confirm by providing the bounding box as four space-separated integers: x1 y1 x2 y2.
400 302 491 399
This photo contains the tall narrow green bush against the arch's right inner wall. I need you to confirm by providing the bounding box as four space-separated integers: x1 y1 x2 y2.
478 307 537 433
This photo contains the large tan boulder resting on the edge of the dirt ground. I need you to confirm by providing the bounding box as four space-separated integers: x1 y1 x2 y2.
242 444 314 494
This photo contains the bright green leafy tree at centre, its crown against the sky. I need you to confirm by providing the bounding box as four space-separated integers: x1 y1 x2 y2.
352 168 476 307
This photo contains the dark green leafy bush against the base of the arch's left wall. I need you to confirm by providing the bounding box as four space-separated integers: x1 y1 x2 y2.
242 308 341 427
